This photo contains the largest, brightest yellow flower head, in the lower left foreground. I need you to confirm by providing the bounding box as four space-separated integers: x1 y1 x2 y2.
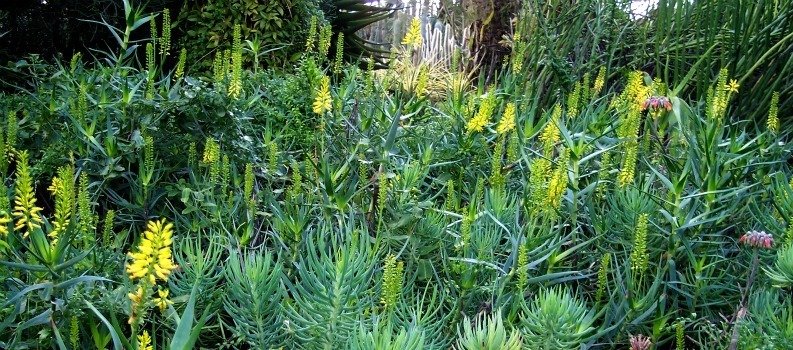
127 220 177 285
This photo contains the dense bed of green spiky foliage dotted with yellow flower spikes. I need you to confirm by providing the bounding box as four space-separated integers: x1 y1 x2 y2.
0 1 793 350
